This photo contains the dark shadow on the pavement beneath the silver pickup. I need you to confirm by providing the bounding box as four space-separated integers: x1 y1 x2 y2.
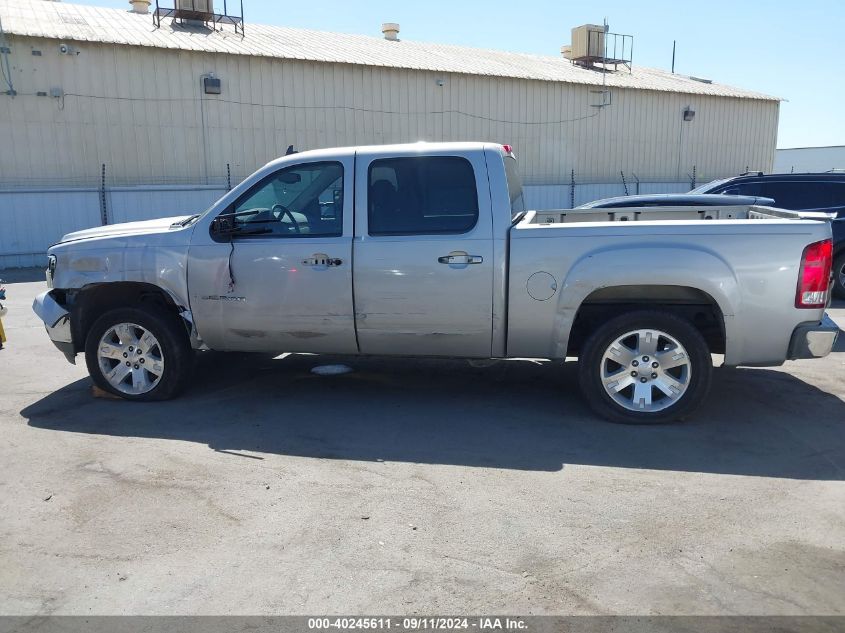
21 353 845 480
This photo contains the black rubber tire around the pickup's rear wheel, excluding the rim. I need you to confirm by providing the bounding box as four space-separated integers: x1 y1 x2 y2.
578 310 713 424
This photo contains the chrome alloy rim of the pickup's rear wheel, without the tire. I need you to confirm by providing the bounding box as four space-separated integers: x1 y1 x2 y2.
600 330 692 412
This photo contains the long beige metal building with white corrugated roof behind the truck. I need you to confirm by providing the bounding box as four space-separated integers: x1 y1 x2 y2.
0 0 779 267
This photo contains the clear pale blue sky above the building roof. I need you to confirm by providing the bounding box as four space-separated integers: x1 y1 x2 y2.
77 0 845 147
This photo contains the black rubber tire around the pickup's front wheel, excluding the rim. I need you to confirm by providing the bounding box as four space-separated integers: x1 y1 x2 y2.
85 307 194 402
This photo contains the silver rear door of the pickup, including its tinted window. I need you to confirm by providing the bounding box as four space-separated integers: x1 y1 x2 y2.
353 151 493 358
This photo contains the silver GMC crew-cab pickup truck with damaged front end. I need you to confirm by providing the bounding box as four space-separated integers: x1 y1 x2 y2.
34 143 838 422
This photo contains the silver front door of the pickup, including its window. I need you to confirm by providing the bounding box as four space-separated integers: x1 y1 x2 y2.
188 156 357 353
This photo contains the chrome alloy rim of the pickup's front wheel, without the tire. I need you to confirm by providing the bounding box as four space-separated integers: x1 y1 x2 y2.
97 323 164 395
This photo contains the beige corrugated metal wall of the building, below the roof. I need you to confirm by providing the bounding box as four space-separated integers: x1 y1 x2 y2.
0 36 778 186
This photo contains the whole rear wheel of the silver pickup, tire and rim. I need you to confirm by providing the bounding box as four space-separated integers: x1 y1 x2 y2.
579 310 713 424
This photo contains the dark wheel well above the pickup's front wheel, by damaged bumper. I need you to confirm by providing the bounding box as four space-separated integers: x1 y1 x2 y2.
65 281 186 352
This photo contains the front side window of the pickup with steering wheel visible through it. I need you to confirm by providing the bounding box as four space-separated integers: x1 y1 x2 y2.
225 162 343 237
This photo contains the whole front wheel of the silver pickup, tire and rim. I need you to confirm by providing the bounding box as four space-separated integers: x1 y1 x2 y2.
85 308 193 401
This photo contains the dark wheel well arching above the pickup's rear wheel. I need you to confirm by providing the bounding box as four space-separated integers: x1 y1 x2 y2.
567 285 725 356
